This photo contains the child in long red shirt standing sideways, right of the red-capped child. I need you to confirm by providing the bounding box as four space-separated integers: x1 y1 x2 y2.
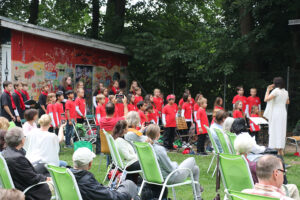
196 98 209 155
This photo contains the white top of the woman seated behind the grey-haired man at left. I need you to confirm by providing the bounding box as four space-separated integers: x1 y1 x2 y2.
25 129 59 166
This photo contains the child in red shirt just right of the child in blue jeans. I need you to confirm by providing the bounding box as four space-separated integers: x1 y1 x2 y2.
75 88 86 124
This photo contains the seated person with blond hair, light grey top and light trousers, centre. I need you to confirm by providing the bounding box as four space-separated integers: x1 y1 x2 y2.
146 124 202 200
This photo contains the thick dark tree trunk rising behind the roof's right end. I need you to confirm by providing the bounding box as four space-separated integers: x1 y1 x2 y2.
103 0 126 42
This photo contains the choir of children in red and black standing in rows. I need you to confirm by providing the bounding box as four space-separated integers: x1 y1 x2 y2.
1 78 261 155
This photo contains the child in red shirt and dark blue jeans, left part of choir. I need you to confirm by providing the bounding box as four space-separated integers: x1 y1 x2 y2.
65 90 76 148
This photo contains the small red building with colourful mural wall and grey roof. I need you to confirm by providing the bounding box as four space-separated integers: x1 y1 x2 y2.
0 16 128 111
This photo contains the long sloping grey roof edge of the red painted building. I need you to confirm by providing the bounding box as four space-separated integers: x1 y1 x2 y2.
0 16 125 54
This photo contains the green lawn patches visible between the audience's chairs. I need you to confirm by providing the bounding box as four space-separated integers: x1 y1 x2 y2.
60 148 300 200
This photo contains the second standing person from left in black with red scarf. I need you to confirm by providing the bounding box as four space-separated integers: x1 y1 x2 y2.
12 82 25 127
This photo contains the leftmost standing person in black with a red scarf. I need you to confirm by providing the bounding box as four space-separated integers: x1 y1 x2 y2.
1 81 20 122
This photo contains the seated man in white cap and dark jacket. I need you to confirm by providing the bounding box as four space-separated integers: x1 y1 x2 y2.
71 147 139 200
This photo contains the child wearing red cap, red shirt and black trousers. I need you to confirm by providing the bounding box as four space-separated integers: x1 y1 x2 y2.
162 94 178 150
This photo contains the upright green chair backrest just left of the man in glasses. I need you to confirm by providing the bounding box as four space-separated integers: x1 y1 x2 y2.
219 153 254 191
